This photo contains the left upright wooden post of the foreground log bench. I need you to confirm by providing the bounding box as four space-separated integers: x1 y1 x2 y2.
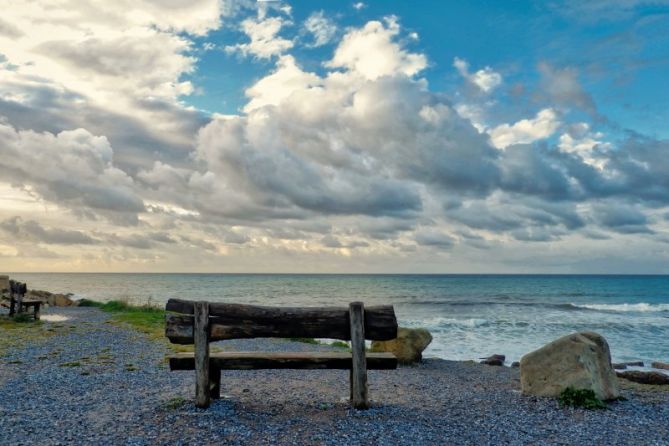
193 302 210 409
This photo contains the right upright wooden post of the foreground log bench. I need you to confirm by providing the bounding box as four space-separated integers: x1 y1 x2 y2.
348 302 369 409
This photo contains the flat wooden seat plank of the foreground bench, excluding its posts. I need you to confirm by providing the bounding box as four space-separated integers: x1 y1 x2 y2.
169 352 397 370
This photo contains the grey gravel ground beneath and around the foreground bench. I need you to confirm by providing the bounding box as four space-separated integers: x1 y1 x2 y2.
0 308 669 445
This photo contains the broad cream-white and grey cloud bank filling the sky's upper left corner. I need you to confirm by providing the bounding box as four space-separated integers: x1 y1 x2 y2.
0 0 211 168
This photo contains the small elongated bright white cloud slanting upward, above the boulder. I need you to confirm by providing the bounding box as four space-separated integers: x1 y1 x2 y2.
489 108 560 149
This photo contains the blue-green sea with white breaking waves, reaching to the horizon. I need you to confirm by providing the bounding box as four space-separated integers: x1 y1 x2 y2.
11 273 669 362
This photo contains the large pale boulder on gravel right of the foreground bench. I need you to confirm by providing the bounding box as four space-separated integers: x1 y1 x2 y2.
520 331 620 400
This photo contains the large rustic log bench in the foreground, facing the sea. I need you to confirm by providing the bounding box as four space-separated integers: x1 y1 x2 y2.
165 299 397 409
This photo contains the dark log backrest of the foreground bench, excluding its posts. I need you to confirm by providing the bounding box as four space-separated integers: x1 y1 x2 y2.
165 299 397 344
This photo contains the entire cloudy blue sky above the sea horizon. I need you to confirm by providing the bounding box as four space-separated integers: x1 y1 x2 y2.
0 0 669 274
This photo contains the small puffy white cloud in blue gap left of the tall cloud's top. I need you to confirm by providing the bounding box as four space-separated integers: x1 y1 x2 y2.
225 17 293 59
